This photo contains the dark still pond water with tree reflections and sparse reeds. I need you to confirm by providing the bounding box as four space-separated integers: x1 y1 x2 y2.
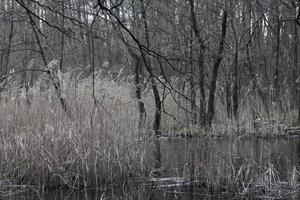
0 138 300 200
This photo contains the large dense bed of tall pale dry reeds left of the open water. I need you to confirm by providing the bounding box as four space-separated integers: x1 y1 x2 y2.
0 70 147 191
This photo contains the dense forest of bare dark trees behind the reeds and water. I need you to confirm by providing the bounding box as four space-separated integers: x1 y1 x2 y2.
0 0 300 134
